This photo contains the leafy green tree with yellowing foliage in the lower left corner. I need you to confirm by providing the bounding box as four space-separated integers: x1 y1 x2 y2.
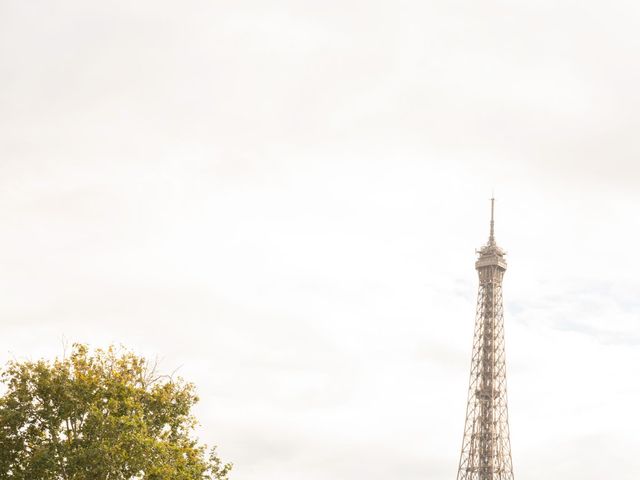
0 344 231 480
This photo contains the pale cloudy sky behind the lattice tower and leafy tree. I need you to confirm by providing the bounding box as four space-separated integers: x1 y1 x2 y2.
0 0 640 480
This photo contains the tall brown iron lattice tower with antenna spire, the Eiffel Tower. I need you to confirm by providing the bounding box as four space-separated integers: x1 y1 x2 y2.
457 199 513 480
